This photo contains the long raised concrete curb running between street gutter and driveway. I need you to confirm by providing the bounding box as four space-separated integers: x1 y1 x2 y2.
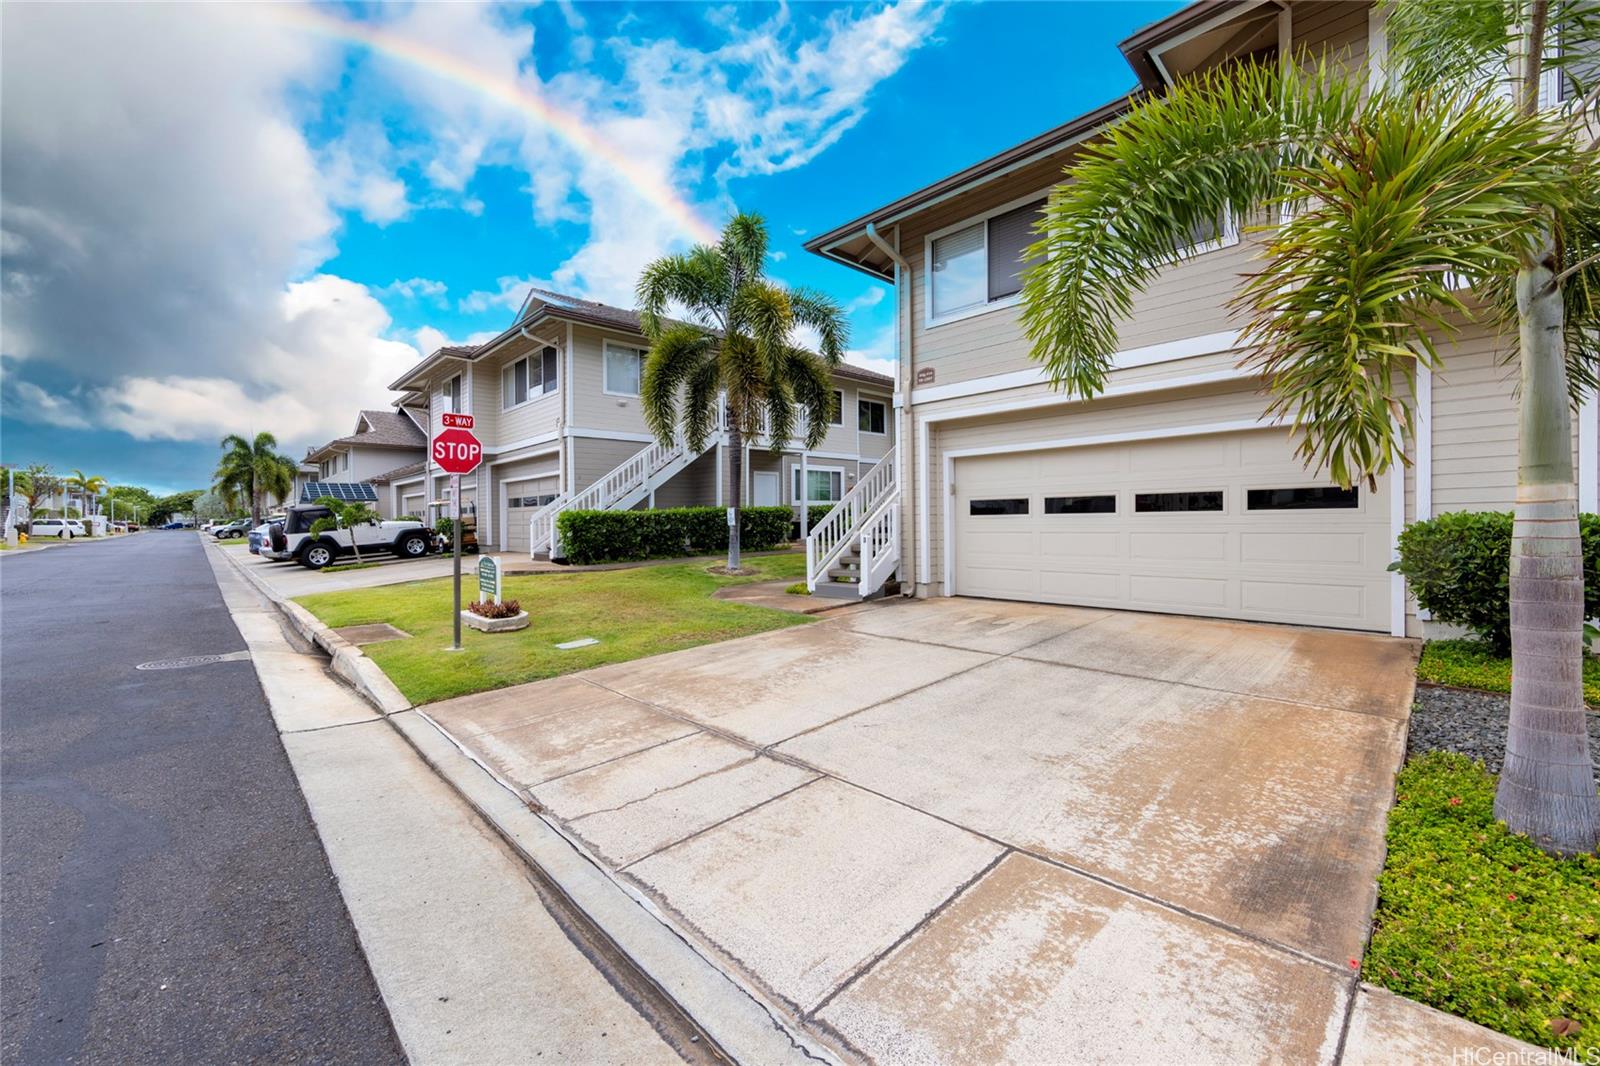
216 549 843 1066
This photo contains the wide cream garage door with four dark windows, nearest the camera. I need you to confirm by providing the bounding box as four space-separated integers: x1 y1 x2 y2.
952 431 1390 631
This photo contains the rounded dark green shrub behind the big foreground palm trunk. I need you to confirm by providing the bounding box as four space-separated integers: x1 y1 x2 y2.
1394 511 1600 655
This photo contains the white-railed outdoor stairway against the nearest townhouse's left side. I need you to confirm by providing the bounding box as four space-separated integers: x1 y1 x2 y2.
805 447 901 600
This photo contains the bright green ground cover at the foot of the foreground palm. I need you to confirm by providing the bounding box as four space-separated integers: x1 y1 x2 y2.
1363 752 1600 1061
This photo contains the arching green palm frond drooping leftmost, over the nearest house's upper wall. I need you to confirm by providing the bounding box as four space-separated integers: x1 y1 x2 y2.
1022 56 1360 395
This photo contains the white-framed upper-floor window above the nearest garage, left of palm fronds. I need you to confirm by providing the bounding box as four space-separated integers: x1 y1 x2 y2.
928 198 1045 320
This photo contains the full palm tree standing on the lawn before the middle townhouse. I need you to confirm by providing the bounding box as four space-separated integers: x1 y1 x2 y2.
638 214 848 570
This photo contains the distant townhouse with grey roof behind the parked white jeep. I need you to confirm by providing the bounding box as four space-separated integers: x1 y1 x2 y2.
296 402 427 519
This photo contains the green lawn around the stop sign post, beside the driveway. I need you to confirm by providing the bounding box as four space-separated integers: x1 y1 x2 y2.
298 552 810 703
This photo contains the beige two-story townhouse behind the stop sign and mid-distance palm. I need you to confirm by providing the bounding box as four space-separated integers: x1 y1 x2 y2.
390 290 894 552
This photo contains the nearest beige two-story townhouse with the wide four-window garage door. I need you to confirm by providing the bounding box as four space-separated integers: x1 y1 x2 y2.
806 0 1600 635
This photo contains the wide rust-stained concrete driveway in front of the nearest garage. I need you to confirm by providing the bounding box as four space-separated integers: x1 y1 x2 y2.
426 599 1416 1063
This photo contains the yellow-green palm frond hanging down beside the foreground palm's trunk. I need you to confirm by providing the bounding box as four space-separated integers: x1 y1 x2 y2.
1235 91 1573 485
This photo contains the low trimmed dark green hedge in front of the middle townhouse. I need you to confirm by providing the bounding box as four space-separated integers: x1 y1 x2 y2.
555 507 795 565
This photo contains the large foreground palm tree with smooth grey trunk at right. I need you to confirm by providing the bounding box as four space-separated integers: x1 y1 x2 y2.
1022 0 1600 853
